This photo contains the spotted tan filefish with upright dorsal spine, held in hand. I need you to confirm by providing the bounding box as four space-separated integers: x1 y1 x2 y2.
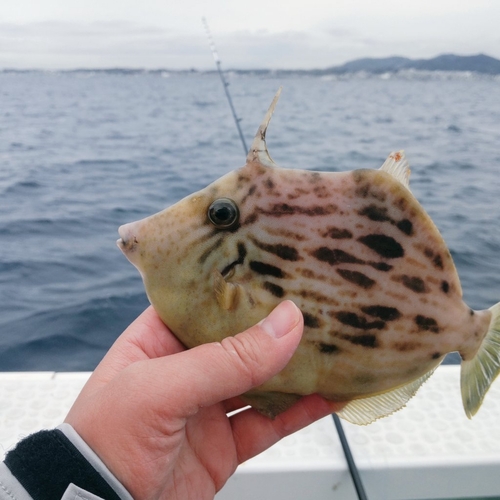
117 89 500 425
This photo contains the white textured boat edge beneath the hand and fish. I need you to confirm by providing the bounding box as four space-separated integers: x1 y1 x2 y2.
0 366 500 500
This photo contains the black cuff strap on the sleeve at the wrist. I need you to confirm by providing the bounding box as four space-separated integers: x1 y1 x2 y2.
5 429 120 500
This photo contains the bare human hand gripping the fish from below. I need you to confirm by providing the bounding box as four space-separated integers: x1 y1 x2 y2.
66 301 343 500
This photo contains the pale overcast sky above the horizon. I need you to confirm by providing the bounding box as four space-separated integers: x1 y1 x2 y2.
0 0 500 70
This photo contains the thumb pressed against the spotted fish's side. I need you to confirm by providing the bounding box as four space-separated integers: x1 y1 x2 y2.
163 301 303 417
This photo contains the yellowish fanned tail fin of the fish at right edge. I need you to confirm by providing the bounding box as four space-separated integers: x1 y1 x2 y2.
460 302 500 418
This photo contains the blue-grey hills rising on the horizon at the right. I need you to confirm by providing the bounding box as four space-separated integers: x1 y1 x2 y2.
322 54 500 75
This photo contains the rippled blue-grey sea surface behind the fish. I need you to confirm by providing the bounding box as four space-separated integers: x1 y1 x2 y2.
0 72 500 371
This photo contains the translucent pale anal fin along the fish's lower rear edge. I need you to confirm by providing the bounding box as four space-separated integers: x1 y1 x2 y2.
337 368 435 425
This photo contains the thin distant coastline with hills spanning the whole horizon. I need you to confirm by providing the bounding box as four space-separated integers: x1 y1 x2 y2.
0 54 500 76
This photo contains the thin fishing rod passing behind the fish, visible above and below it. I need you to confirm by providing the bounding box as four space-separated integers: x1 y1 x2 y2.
202 17 368 500
